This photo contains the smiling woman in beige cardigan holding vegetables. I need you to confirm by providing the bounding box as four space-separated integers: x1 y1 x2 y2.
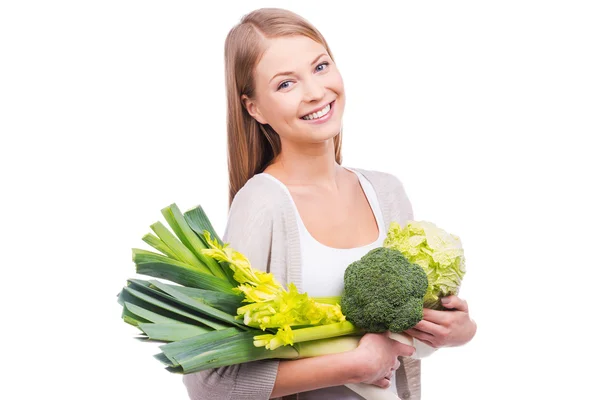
184 9 475 400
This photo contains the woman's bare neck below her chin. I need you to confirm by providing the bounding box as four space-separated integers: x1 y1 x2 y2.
266 138 341 188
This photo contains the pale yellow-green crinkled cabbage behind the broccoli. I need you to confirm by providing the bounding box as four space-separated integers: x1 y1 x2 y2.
383 221 466 310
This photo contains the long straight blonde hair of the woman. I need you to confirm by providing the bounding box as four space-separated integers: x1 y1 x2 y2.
225 8 342 205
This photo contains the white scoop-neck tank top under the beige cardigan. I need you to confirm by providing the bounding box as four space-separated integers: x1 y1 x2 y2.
264 168 397 400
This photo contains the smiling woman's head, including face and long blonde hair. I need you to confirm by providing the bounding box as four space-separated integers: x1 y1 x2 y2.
225 16 345 203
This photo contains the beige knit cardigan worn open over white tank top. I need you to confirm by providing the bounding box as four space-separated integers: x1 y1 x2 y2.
183 168 421 400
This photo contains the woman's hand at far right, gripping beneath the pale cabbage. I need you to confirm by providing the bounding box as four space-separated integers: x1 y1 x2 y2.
405 296 477 349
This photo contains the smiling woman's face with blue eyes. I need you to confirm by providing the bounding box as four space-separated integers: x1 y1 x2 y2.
243 36 345 144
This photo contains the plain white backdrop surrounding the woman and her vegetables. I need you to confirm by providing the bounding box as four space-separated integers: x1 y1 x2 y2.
0 0 600 400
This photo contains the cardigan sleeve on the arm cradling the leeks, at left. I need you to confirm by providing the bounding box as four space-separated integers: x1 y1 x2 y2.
183 180 279 400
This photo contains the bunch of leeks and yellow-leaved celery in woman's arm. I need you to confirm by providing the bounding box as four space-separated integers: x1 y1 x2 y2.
118 204 358 373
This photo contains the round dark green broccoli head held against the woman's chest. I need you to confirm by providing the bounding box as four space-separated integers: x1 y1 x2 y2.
341 247 427 333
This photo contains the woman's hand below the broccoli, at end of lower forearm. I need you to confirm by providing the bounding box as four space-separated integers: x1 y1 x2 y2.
352 333 415 388
